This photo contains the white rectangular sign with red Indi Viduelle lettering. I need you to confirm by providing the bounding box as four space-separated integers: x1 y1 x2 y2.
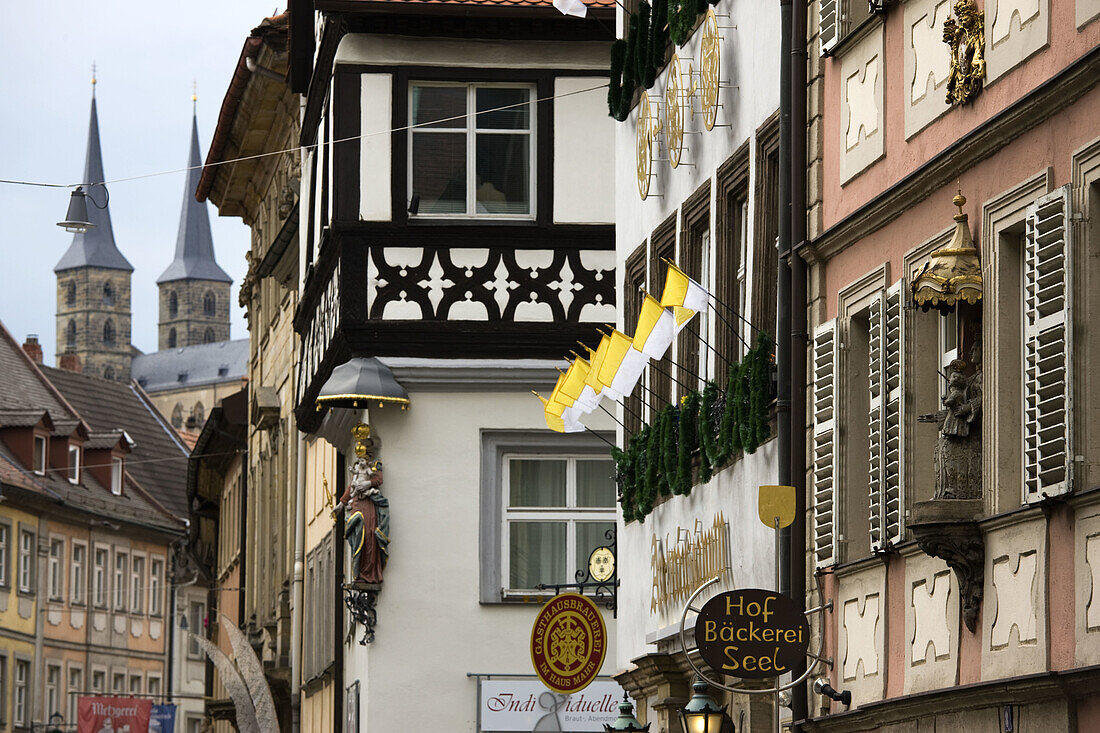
479 679 623 733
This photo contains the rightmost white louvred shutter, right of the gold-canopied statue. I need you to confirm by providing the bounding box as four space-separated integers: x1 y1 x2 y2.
1023 186 1074 502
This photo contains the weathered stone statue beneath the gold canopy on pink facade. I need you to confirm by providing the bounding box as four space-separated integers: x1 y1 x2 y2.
917 342 981 499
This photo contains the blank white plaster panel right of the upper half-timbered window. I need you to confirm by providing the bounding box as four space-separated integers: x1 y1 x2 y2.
553 76 617 223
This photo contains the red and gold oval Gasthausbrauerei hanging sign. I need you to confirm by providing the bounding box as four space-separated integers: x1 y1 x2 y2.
531 593 607 694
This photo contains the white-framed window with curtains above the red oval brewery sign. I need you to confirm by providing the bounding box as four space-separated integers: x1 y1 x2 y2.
502 455 615 592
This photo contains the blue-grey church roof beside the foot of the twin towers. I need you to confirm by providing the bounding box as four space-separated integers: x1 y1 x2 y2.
130 339 249 393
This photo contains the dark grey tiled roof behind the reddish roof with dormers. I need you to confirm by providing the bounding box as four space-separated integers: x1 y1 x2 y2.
44 368 189 518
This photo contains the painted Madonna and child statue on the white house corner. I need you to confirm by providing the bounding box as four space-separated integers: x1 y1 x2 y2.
340 458 389 584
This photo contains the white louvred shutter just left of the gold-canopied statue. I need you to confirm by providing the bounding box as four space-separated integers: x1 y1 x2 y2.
867 281 903 551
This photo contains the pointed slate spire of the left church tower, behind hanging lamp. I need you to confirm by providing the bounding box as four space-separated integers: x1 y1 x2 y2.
54 88 134 272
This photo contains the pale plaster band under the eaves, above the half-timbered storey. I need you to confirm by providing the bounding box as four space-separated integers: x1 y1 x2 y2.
336 33 609 69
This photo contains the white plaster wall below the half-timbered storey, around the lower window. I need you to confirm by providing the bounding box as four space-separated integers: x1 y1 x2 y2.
344 385 616 733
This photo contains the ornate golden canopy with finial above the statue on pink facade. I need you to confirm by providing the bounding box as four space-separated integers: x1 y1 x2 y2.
912 190 982 314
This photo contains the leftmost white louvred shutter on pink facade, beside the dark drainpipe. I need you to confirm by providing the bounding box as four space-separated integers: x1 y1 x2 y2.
812 319 837 568
